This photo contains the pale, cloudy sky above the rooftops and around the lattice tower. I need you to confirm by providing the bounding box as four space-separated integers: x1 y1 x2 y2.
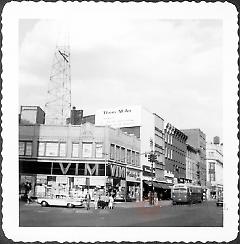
19 16 222 141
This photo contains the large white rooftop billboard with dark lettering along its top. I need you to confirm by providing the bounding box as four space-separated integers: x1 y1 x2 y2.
95 105 141 128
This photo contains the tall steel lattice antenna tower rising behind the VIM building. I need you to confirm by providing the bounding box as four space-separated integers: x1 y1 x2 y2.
45 30 71 125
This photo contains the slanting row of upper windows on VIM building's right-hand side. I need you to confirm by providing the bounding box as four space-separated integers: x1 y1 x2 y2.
110 144 140 166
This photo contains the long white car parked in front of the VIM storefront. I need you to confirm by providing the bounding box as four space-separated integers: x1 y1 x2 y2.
37 197 83 208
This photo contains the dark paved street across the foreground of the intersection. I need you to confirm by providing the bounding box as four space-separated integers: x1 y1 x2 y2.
20 201 223 227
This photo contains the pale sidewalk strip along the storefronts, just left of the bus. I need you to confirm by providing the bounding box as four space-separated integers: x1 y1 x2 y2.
114 200 172 208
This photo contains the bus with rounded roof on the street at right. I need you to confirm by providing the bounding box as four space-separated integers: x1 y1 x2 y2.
172 184 203 205
